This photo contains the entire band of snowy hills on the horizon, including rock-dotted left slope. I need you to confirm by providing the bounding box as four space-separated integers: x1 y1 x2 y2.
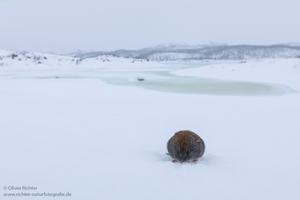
0 44 300 66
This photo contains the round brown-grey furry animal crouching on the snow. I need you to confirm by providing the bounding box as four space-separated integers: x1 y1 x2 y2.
167 131 205 162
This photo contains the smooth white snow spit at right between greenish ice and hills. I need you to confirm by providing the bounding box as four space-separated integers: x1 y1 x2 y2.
173 59 300 89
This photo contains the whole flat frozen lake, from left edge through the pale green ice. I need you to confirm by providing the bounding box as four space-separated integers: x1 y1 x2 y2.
0 63 294 96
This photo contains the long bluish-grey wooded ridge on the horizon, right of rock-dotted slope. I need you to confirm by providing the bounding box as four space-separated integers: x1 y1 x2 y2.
75 44 300 61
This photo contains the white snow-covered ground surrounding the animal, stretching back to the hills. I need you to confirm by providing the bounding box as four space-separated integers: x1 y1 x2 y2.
0 59 300 200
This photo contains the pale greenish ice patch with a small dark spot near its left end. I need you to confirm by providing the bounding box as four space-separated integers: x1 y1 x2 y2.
103 72 294 96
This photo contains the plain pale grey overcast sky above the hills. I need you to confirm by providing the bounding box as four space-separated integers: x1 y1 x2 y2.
0 0 300 52
